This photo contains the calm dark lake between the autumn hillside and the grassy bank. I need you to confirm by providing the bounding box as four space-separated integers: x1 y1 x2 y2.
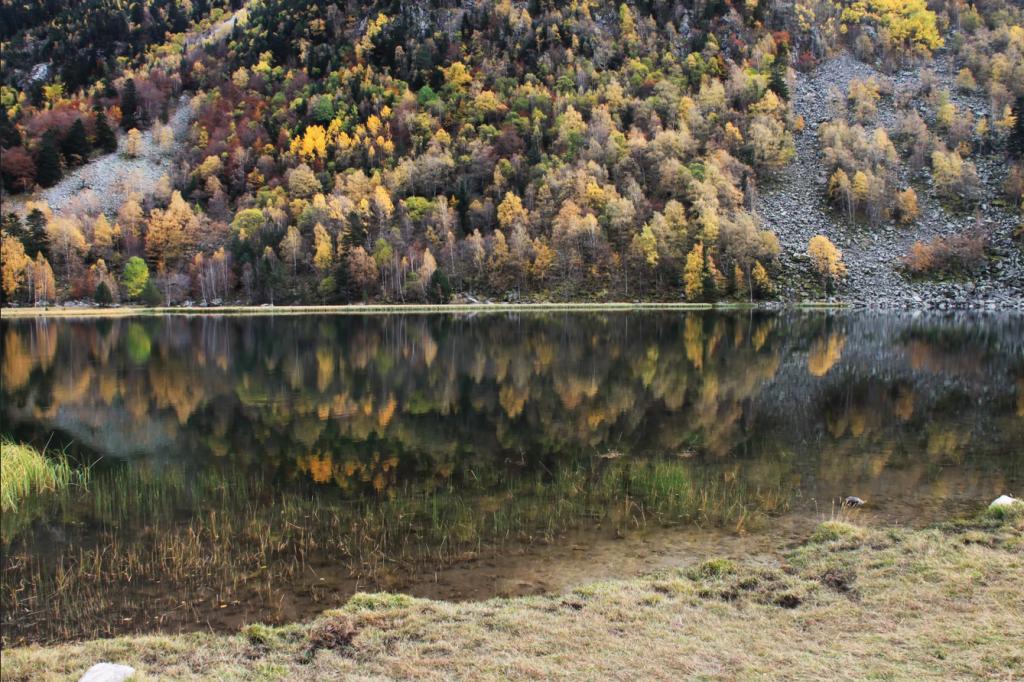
0 311 1024 645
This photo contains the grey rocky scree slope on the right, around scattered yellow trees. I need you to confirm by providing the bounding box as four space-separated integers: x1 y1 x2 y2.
755 53 1024 309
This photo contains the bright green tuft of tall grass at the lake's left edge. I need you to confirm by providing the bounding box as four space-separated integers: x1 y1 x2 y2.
0 439 88 512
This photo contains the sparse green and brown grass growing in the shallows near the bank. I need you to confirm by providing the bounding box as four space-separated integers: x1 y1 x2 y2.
0 459 790 644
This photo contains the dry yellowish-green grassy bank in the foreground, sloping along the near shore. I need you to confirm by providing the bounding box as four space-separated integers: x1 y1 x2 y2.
3 507 1024 680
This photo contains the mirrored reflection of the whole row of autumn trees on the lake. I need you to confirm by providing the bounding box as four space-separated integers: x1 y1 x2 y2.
2 313 1024 492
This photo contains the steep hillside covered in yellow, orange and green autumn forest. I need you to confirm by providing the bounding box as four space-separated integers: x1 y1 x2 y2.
0 0 1024 304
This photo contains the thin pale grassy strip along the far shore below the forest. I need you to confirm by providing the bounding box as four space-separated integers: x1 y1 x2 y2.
0 302 845 319
